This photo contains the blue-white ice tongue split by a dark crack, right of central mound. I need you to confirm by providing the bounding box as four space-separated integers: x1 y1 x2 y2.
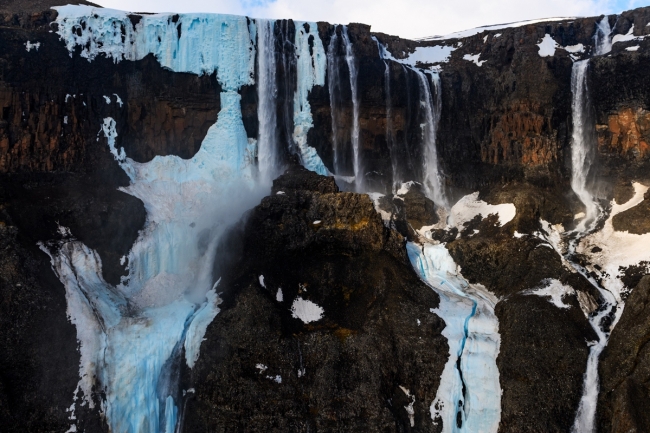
407 242 501 433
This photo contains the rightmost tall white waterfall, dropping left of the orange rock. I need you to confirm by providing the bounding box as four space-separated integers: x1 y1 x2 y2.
571 60 600 232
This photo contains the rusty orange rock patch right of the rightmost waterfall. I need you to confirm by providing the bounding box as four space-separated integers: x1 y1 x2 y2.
596 107 650 159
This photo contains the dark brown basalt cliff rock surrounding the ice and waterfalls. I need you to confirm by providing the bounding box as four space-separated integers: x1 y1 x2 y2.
0 1 650 433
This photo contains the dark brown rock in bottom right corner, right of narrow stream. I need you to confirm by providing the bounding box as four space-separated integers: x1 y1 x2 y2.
598 276 650 433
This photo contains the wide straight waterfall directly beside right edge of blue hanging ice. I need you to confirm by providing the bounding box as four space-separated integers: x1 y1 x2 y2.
257 20 280 183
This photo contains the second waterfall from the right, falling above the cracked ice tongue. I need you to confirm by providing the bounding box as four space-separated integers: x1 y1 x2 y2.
413 68 448 208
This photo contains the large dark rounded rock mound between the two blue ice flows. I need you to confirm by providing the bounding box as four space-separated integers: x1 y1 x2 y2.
180 168 449 432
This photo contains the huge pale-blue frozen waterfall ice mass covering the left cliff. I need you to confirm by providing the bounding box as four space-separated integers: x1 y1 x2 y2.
52 6 280 433
